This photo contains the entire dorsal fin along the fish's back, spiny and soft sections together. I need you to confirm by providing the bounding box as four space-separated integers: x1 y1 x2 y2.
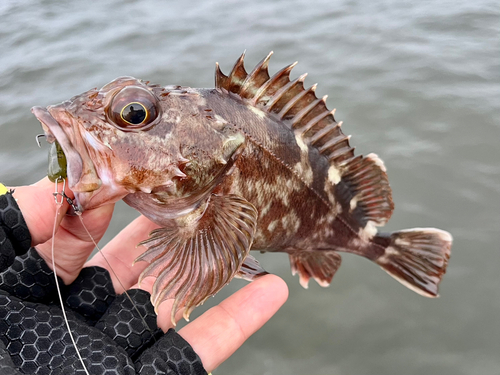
215 52 394 226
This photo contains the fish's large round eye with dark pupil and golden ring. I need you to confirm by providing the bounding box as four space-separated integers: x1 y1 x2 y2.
108 86 159 131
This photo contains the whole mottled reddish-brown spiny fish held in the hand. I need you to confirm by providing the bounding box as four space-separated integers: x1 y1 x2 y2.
33 54 452 319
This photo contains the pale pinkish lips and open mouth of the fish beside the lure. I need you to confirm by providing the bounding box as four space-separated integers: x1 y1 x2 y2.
31 106 101 212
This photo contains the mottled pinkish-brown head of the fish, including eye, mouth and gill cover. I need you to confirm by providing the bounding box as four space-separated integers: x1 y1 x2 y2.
32 77 243 217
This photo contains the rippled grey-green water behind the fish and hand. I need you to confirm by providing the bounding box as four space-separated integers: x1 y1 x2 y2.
0 0 500 375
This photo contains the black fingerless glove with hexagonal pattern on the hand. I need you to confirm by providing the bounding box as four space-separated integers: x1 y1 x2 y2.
0 193 206 375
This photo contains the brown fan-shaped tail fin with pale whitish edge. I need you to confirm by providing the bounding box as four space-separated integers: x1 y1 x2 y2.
374 228 452 297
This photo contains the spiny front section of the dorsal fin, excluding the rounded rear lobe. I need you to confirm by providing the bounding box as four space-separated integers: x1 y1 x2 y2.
215 52 354 167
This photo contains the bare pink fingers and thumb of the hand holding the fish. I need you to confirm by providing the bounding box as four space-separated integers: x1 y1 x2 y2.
5 179 288 371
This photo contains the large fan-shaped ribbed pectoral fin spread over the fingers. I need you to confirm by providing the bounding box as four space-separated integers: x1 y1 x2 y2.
136 195 257 324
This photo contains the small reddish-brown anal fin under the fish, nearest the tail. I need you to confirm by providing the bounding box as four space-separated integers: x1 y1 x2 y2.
289 250 342 289
